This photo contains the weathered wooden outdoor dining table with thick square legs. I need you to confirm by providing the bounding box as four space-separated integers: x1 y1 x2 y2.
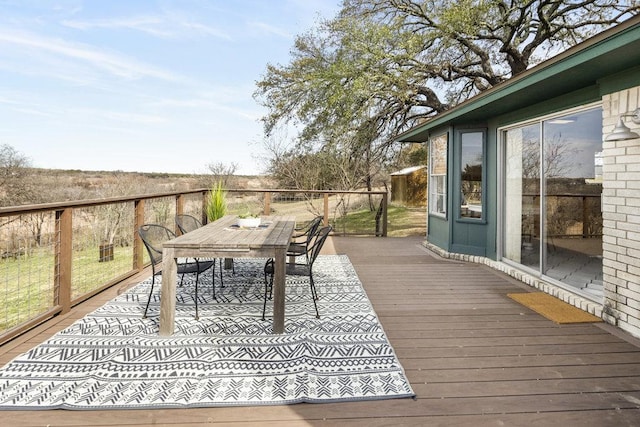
160 215 296 335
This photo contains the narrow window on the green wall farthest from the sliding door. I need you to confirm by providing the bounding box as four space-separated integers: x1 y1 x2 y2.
429 133 447 216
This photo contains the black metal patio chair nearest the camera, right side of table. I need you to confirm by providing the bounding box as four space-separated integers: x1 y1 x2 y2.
262 225 332 320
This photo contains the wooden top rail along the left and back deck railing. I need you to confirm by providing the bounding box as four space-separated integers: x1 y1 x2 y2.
0 188 387 217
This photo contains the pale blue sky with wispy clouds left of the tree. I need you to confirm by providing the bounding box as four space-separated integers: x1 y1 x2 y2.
0 0 339 174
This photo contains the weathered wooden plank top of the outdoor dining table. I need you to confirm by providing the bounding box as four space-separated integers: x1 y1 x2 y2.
163 215 295 251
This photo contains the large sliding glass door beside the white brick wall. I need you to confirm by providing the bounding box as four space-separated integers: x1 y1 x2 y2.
502 108 602 296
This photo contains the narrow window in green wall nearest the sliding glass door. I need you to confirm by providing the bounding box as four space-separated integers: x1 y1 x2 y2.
460 131 484 218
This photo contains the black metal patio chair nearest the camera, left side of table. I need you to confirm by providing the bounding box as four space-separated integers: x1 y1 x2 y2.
138 224 215 319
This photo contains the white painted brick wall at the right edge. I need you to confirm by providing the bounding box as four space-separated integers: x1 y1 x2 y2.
602 87 640 337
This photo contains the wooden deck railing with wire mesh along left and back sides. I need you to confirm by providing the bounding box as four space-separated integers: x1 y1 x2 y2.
0 189 387 344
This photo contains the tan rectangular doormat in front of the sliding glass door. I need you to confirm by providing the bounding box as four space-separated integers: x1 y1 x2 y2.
507 292 602 324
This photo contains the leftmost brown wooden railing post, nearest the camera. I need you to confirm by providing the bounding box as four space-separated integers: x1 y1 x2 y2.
54 208 73 313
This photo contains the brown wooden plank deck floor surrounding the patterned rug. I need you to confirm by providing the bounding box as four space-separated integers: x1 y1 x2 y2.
0 238 640 427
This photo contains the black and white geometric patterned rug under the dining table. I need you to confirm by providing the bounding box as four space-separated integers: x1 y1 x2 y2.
0 255 414 410
